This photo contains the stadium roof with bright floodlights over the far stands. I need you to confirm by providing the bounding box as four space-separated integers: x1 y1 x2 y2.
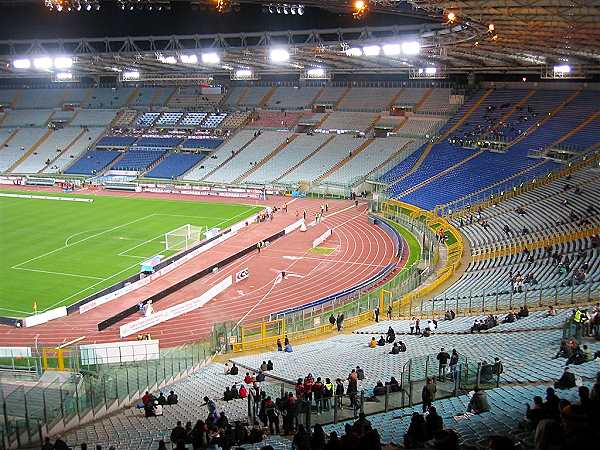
0 0 600 79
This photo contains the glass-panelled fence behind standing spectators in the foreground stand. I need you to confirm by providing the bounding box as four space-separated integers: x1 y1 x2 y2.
248 354 500 427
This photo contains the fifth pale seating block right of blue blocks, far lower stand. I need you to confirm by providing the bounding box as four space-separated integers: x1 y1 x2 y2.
325 137 418 184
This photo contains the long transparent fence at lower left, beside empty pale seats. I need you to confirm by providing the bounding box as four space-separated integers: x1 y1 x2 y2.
0 324 231 450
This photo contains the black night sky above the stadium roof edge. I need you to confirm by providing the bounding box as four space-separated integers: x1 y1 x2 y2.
0 0 434 40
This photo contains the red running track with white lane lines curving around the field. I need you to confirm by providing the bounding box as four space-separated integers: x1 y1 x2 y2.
0 186 404 347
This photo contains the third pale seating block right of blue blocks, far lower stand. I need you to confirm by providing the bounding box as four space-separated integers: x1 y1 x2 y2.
245 133 332 183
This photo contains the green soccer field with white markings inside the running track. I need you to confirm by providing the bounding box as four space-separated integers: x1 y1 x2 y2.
0 191 261 317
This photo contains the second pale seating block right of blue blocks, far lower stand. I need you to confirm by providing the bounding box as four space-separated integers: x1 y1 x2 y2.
206 131 291 183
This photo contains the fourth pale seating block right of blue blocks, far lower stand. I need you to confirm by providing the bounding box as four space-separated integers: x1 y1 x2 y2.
280 134 365 183
